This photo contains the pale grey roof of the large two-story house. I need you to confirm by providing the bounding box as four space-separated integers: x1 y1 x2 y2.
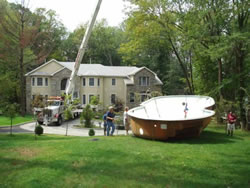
25 59 162 84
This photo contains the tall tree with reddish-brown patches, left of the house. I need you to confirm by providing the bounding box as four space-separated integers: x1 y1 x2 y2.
0 0 67 115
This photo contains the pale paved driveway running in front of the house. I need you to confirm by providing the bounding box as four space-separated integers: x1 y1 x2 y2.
20 118 132 136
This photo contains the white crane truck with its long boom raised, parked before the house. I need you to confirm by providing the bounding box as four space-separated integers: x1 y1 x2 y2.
37 0 102 125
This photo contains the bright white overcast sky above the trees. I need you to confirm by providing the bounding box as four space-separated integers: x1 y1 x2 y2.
8 0 129 31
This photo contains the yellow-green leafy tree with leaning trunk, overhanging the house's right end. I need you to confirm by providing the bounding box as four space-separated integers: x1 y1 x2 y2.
120 0 191 94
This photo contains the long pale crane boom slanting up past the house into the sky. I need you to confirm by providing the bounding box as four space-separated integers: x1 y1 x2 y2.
66 0 102 95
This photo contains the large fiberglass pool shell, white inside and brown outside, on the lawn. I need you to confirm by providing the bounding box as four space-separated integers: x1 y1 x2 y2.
128 95 215 140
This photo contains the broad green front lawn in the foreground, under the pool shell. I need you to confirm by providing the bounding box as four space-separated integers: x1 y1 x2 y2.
0 122 250 188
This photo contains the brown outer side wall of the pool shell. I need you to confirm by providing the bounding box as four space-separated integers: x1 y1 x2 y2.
130 117 211 140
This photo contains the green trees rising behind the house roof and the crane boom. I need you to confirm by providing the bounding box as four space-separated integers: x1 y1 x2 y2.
63 20 124 66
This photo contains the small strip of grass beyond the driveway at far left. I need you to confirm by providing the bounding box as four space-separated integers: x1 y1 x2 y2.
0 115 33 127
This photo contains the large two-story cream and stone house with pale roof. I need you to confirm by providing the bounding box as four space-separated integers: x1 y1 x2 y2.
26 59 162 112
